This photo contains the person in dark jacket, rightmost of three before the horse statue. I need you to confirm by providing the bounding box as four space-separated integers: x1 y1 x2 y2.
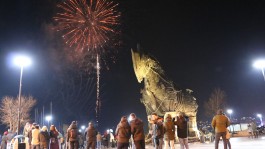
174 112 189 149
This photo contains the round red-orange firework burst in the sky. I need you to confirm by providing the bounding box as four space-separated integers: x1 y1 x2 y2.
54 0 120 54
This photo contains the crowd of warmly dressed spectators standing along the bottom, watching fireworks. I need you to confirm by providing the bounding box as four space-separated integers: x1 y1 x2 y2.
4 109 258 149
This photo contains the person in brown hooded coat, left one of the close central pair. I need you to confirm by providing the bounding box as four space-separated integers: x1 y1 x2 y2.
115 116 131 149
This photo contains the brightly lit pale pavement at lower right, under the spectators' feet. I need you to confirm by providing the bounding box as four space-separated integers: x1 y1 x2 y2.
146 136 265 149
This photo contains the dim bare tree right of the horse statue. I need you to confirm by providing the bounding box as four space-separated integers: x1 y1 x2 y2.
204 88 226 117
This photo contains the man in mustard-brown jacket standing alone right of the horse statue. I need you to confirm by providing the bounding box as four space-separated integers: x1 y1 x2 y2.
212 109 230 149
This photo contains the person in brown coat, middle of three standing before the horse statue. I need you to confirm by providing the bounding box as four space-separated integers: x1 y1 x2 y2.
163 114 175 149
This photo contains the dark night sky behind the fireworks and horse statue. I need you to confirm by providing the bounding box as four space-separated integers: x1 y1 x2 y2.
0 0 265 133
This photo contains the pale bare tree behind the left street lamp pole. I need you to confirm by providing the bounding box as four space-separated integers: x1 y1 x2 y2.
0 96 36 132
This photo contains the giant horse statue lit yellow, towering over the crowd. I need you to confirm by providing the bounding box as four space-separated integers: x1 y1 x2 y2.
131 50 198 137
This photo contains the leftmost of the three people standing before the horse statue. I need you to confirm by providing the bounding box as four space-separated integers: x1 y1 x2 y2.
150 113 164 149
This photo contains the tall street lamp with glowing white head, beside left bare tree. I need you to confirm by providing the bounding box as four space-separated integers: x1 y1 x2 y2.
14 56 31 134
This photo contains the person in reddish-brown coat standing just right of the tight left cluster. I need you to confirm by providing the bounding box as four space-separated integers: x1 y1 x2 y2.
66 121 79 149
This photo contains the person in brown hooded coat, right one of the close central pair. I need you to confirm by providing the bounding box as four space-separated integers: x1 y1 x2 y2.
130 113 145 149
